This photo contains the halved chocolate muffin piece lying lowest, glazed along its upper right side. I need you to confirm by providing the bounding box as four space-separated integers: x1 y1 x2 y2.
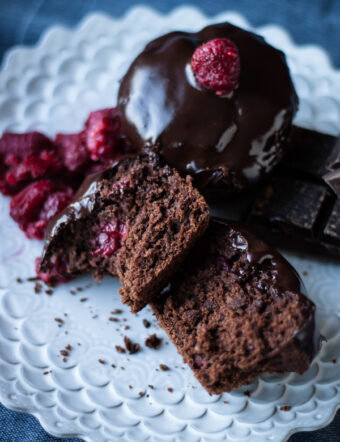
152 218 320 393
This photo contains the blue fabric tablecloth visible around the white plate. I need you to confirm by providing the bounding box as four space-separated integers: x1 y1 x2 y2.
0 0 340 442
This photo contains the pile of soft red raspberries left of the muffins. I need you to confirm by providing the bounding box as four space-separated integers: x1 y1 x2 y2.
0 108 131 239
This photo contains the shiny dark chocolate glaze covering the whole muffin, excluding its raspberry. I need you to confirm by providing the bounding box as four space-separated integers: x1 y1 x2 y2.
118 23 298 195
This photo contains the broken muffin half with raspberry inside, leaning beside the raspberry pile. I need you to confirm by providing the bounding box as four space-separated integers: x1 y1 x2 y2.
40 153 209 312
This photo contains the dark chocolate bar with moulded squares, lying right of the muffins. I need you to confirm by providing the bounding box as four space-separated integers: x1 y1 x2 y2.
247 127 340 257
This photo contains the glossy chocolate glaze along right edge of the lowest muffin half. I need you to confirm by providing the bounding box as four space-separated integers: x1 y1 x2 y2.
210 218 323 361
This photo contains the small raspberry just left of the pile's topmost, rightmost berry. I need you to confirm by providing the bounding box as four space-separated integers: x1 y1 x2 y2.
54 131 90 173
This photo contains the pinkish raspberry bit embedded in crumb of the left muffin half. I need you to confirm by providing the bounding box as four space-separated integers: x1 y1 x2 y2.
92 221 126 258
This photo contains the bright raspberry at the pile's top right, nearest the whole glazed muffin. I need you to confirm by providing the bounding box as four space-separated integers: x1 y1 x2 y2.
85 108 121 161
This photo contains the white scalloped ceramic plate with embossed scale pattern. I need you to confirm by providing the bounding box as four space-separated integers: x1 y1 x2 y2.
0 7 340 442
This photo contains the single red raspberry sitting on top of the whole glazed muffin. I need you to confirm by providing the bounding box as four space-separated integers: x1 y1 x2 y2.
191 38 241 95
